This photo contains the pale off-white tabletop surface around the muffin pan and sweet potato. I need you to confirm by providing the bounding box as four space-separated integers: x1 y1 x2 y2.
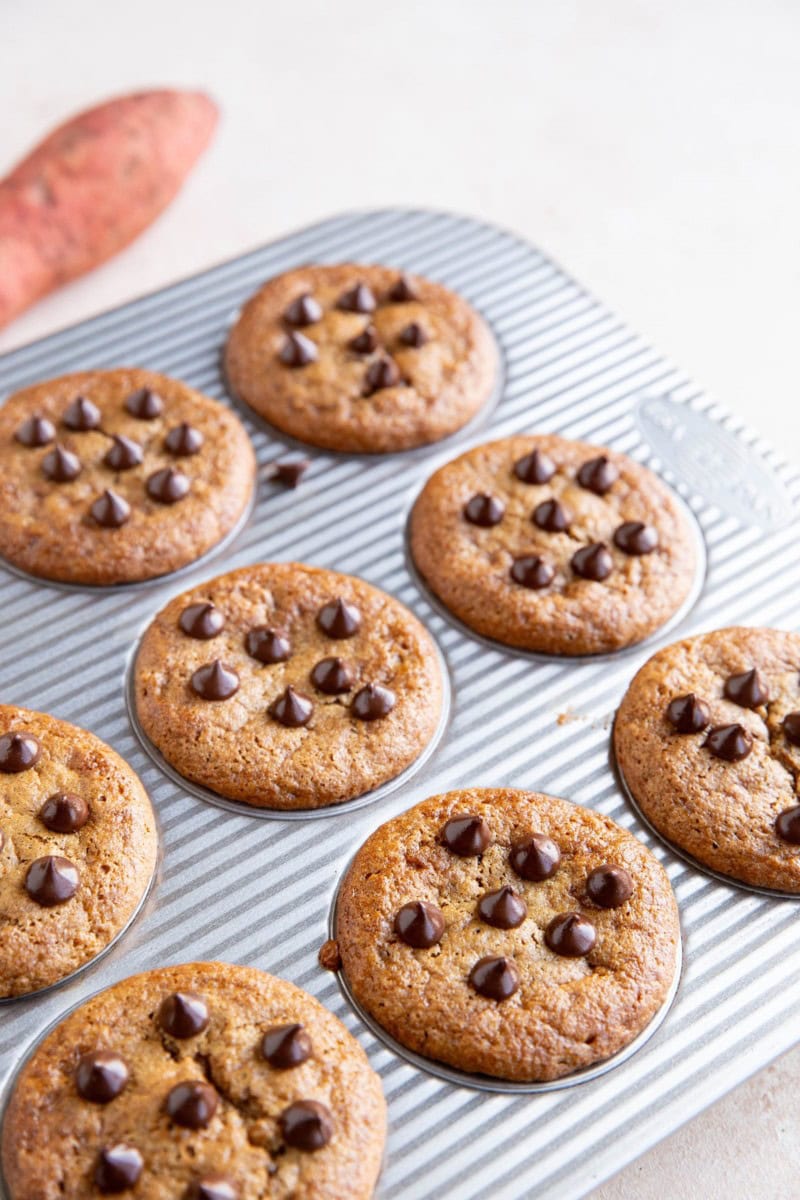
0 0 800 1200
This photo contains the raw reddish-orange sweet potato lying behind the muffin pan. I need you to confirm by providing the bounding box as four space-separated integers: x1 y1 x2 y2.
0 90 217 328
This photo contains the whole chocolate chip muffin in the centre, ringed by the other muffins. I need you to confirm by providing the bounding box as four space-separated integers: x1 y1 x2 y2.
134 563 443 809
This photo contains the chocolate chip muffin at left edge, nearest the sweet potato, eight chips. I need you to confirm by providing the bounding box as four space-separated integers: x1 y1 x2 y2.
0 368 255 584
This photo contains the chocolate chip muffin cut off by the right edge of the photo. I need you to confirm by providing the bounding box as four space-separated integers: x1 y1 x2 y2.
614 628 800 893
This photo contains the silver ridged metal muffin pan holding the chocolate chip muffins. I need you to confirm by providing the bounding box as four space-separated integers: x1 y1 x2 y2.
0 211 800 1200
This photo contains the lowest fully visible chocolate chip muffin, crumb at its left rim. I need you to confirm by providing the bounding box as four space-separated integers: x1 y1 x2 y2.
336 787 680 1082
